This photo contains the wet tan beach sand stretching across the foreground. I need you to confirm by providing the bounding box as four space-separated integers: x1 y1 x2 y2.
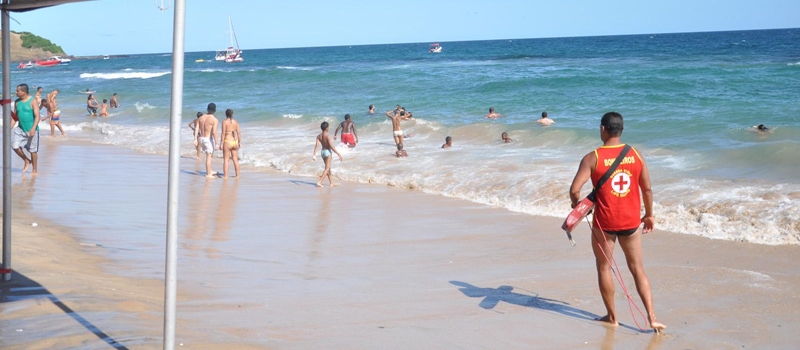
0 137 800 349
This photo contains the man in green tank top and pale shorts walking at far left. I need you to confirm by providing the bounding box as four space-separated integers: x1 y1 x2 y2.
11 84 40 175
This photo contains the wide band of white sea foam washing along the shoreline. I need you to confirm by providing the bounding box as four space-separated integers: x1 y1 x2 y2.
65 119 800 244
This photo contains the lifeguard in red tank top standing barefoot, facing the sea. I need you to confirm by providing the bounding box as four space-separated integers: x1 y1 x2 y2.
569 112 666 332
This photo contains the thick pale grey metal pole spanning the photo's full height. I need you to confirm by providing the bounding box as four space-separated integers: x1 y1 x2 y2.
164 0 186 350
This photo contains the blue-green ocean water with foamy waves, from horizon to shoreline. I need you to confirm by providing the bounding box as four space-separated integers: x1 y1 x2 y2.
11 29 800 244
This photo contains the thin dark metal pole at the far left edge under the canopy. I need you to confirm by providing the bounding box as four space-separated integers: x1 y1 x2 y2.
0 0 12 281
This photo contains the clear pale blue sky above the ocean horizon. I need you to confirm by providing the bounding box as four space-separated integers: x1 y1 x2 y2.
11 0 800 56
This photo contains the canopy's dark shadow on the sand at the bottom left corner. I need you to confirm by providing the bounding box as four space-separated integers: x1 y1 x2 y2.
0 271 127 349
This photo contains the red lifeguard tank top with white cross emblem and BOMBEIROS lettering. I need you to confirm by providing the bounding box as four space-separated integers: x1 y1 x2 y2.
592 144 642 231
